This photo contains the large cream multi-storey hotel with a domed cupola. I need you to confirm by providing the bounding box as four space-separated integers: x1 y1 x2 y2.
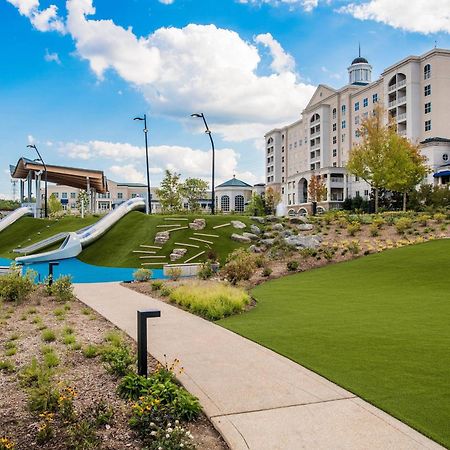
265 49 450 214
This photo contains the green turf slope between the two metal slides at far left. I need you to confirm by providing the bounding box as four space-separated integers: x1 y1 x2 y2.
0 216 99 259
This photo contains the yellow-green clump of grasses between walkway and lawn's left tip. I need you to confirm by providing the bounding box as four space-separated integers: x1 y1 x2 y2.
169 281 250 320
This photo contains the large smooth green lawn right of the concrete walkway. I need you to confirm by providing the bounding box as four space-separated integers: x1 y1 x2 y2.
219 240 450 447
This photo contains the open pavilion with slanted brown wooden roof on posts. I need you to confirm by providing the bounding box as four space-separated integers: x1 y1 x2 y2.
10 157 108 217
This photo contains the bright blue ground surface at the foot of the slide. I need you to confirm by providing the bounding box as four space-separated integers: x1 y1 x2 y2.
0 258 165 283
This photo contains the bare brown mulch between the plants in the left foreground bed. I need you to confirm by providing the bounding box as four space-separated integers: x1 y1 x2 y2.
0 292 228 450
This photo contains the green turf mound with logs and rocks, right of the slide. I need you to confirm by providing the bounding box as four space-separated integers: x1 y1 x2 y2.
79 211 250 269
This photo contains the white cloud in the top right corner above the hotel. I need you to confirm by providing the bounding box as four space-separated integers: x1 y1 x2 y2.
339 0 450 34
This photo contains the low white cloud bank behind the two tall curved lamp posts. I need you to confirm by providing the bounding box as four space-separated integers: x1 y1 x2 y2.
59 141 255 183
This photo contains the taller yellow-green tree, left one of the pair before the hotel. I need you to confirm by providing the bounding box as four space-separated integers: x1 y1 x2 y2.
347 105 396 212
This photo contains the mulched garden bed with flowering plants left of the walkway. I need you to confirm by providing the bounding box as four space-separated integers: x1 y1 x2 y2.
0 272 227 450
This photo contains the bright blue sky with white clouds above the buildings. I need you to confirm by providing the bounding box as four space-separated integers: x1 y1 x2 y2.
0 0 450 198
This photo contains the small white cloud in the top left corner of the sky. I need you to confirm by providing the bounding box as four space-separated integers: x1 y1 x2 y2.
6 0 65 33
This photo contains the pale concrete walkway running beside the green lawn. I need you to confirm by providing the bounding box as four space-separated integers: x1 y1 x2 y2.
75 283 442 450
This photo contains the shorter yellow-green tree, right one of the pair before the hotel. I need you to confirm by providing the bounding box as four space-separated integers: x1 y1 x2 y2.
386 133 430 211
